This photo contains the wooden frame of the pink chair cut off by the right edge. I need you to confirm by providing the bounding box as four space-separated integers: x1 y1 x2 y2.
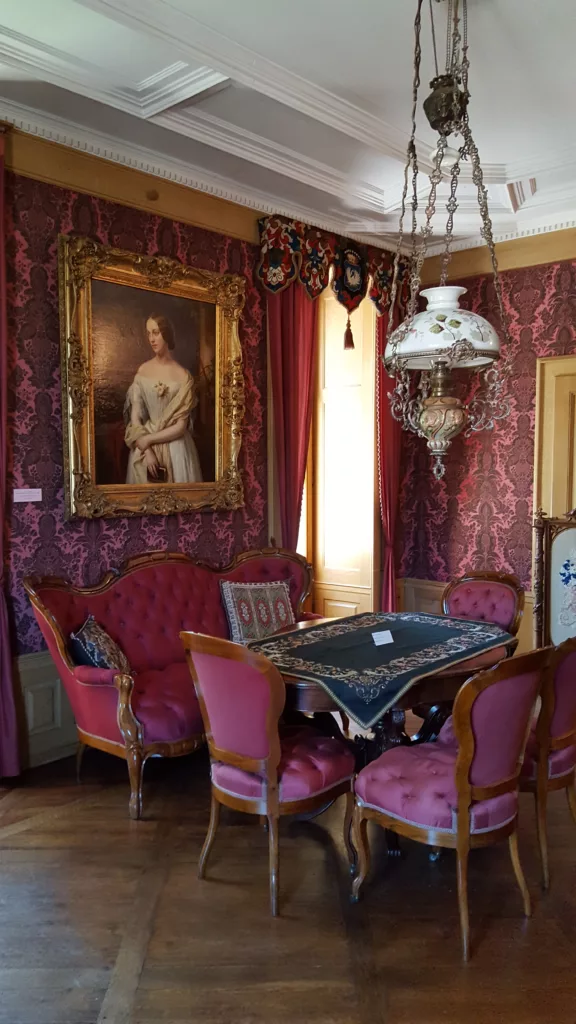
520 637 576 889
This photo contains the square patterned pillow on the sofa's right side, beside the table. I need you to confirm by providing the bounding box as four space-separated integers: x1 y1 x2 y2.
220 580 295 643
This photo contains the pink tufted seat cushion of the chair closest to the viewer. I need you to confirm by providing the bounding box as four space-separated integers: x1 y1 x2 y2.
355 742 518 833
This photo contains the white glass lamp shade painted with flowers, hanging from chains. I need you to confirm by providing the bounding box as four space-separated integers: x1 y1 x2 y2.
384 285 500 370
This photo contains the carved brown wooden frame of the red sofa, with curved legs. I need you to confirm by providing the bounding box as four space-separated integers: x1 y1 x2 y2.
24 548 312 818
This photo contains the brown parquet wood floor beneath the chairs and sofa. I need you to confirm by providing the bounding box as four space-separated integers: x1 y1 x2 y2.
0 752 576 1024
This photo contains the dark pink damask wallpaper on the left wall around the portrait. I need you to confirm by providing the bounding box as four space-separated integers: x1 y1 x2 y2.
7 175 266 653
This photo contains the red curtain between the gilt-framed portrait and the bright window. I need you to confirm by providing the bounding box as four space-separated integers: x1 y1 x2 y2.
268 284 318 551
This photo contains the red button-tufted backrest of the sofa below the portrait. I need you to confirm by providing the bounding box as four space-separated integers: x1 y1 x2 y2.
29 551 308 672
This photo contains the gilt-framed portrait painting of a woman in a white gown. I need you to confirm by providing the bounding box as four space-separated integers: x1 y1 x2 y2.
58 237 246 518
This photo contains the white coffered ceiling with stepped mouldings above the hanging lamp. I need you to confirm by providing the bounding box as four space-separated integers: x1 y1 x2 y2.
0 0 576 247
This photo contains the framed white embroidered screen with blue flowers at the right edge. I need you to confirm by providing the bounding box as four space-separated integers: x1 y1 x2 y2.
534 509 576 647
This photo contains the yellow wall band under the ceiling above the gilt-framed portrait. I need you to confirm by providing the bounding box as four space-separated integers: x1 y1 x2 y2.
6 129 262 243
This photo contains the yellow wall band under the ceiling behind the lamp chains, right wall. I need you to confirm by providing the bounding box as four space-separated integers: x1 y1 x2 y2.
421 227 576 285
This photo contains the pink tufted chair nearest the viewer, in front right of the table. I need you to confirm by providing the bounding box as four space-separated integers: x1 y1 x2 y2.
353 649 549 959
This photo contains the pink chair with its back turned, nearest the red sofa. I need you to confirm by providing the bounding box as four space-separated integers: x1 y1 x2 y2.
180 632 355 916
